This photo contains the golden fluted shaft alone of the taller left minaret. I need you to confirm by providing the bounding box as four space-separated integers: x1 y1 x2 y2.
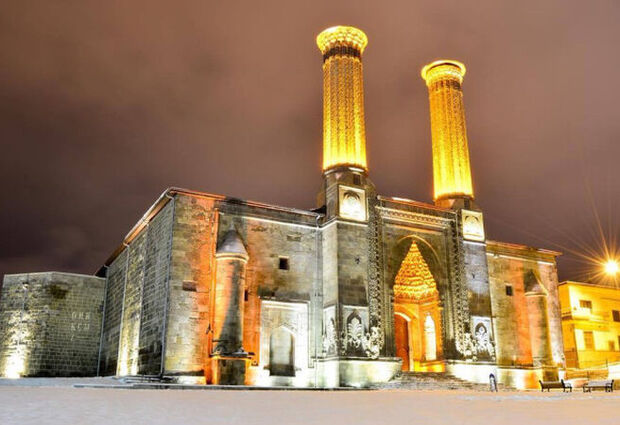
317 26 368 172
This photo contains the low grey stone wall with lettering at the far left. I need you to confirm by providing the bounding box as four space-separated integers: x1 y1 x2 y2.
0 272 105 377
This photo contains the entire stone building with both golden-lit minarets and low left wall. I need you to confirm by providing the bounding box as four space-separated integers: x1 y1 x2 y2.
0 26 564 388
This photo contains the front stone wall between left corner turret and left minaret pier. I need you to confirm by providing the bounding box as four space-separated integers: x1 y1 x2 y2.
218 203 322 383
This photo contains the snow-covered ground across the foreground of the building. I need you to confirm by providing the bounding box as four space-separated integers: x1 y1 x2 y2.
0 379 620 425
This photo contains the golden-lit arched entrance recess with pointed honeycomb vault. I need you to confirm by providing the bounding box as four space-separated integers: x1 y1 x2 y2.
394 241 444 372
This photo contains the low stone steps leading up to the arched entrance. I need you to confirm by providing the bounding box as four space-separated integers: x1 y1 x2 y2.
375 372 505 392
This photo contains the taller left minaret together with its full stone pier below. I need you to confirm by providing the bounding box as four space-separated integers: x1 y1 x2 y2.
314 26 389 372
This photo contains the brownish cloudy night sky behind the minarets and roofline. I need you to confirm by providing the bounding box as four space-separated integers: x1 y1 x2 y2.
0 0 620 279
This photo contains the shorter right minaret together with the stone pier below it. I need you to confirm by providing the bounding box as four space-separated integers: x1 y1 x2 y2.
422 60 495 360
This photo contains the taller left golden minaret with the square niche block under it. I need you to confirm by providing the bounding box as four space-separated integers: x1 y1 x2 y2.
316 26 375 222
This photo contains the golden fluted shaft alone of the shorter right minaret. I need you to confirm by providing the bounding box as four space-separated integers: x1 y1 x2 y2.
422 60 474 208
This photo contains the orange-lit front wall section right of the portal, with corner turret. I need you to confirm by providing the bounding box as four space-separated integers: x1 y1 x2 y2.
487 242 564 386
